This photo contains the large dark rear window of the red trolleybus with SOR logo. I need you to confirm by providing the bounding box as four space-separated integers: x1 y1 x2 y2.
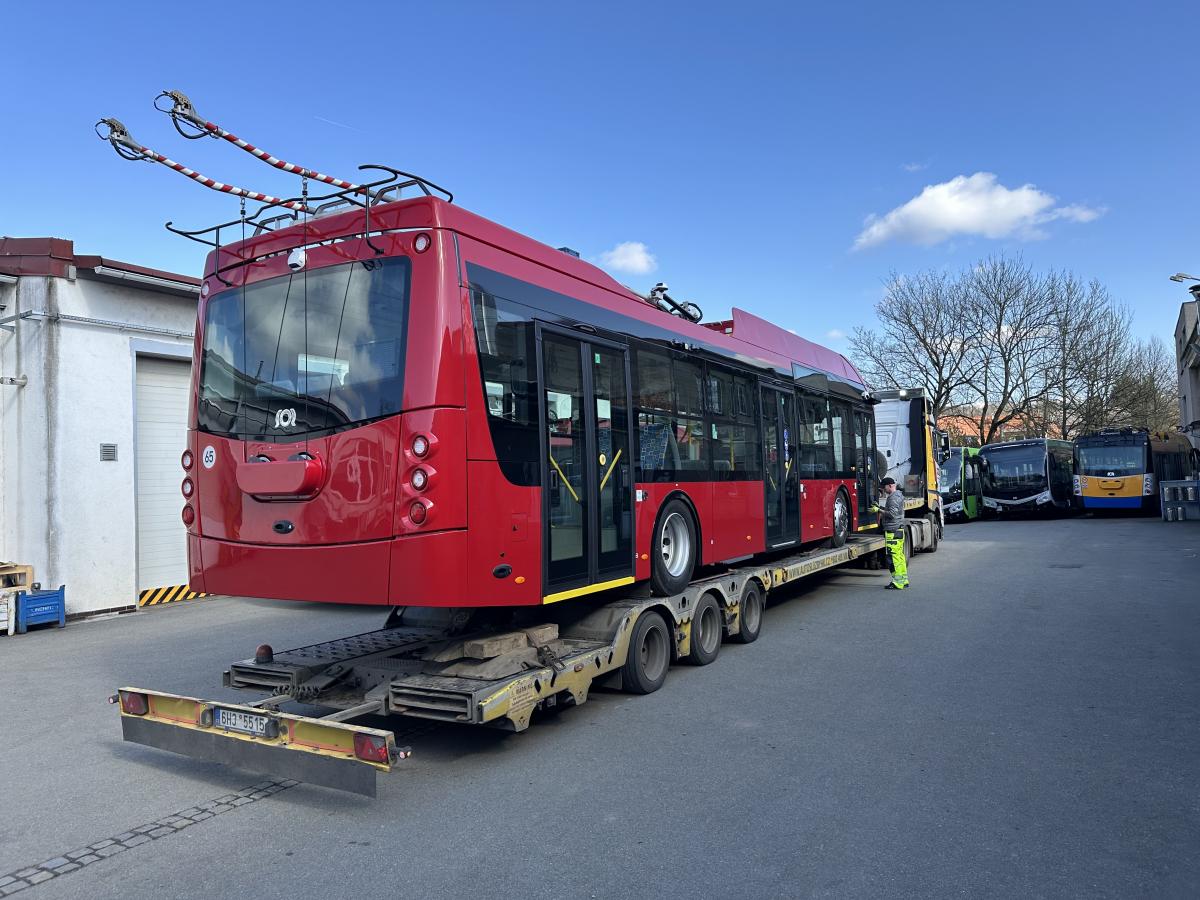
198 257 409 443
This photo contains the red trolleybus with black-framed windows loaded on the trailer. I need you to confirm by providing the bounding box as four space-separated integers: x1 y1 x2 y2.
184 180 875 607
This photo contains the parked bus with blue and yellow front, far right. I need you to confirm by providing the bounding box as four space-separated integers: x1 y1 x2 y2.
1075 428 1193 511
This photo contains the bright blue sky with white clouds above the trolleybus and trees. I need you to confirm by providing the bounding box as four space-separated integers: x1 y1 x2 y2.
0 2 1200 349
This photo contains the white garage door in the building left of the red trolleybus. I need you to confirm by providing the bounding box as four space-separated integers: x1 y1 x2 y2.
137 356 192 605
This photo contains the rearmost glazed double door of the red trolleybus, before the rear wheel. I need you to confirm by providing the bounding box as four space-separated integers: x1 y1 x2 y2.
538 326 634 595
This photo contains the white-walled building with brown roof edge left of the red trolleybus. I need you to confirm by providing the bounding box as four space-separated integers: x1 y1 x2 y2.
0 238 199 614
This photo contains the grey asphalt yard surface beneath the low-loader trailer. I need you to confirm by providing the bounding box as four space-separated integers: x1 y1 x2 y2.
0 518 1200 900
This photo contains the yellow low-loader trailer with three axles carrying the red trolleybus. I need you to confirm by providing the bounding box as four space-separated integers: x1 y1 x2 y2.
113 534 883 797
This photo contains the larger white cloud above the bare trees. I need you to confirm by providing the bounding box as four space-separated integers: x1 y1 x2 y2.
854 172 1104 250
